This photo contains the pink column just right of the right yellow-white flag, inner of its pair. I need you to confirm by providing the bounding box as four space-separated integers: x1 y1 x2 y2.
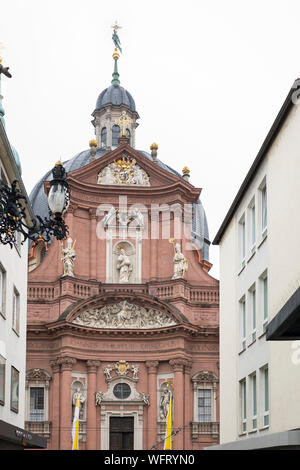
169 358 186 450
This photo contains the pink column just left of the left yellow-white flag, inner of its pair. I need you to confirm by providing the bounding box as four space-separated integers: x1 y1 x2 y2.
58 356 76 450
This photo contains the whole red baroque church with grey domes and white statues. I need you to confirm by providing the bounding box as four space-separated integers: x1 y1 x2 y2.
25 39 219 450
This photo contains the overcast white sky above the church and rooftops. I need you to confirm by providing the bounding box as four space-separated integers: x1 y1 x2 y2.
0 0 300 278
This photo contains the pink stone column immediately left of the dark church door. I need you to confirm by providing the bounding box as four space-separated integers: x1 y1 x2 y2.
86 361 100 450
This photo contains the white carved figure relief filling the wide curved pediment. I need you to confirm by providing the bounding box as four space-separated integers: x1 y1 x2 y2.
72 300 178 330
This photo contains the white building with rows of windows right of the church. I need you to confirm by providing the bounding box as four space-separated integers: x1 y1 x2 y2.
213 80 300 450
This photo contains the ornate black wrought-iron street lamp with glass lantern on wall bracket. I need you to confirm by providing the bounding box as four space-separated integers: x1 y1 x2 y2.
0 162 70 247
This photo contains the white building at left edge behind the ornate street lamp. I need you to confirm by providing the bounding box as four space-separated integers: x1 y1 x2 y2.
0 68 46 449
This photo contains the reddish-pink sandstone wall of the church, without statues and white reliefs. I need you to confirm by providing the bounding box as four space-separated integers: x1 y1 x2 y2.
27 146 219 449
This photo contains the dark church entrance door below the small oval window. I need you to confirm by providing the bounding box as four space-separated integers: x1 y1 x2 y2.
109 416 134 450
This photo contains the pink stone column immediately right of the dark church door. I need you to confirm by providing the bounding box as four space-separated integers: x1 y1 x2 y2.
146 361 159 449
